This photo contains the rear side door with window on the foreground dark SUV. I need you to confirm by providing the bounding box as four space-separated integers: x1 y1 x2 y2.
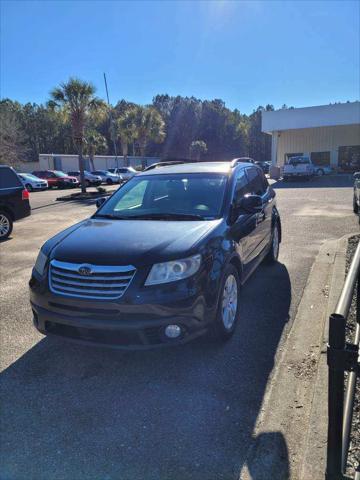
246 167 275 256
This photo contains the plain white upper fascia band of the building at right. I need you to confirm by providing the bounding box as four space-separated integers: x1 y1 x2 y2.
261 102 360 133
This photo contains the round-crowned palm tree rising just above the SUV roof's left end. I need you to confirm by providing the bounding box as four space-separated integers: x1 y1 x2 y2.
129 106 166 168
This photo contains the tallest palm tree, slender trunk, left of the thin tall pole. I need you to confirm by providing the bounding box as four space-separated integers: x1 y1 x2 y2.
50 78 104 193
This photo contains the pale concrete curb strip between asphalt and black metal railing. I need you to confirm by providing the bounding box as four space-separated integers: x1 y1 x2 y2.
240 235 352 480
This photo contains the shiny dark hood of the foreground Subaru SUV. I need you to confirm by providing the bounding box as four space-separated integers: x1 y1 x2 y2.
51 218 222 266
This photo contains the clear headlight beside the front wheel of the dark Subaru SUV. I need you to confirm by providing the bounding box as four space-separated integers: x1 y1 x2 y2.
145 255 201 285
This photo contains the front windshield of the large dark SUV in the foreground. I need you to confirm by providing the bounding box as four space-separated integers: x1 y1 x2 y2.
95 173 227 220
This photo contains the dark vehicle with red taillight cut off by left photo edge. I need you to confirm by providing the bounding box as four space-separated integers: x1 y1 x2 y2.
0 165 31 240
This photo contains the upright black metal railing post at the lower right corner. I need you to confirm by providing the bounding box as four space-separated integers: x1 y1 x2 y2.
326 314 345 480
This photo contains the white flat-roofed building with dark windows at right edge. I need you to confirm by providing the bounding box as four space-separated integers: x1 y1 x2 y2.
262 102 360 171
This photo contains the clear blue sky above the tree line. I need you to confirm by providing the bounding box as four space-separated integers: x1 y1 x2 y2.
0 0 360 113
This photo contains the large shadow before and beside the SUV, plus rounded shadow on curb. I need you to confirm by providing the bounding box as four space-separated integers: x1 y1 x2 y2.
0 263 291 480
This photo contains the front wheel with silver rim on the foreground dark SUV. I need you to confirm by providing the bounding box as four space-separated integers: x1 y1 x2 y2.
209 264 240 341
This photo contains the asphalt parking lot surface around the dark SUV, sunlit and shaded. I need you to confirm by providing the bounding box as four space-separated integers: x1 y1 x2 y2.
0 176 359 480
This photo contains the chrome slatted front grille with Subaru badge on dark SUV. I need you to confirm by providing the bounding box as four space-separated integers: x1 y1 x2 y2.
49 260 136 300
